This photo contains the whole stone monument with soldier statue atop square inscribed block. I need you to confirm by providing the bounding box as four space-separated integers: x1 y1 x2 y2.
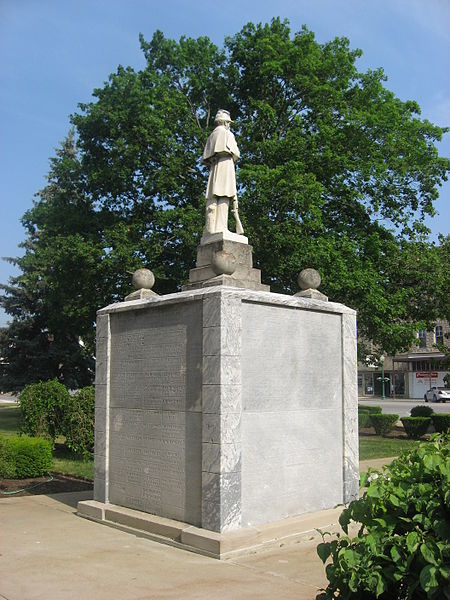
78 110 359 558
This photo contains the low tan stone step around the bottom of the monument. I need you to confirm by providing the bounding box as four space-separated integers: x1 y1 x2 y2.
77 500 342 560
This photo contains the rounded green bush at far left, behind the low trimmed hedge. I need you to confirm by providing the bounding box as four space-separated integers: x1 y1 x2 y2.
19 379 70 439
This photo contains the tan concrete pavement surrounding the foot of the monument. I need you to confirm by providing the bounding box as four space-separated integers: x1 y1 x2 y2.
0 459 389 600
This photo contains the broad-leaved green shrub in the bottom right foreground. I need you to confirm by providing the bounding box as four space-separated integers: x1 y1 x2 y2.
317 435 450 600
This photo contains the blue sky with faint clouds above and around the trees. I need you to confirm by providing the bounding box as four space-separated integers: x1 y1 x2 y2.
0 0 450 326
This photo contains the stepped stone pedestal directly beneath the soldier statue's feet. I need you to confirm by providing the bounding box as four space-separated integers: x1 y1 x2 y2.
182 231 270 292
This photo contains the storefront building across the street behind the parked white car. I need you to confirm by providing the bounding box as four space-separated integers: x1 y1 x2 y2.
358 320 450 399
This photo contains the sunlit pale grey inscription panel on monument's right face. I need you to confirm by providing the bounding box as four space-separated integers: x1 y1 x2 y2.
242 303 343 526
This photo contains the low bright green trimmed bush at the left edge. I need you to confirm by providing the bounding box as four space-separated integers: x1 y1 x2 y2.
0 436 53 479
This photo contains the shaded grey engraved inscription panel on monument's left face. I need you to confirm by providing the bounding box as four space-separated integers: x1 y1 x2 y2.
109 302 202 525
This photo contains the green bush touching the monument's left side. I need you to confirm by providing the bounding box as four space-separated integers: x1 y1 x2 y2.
62 385 95 456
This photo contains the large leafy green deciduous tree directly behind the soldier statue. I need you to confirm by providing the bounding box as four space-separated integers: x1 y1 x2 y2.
4 19 449 390
